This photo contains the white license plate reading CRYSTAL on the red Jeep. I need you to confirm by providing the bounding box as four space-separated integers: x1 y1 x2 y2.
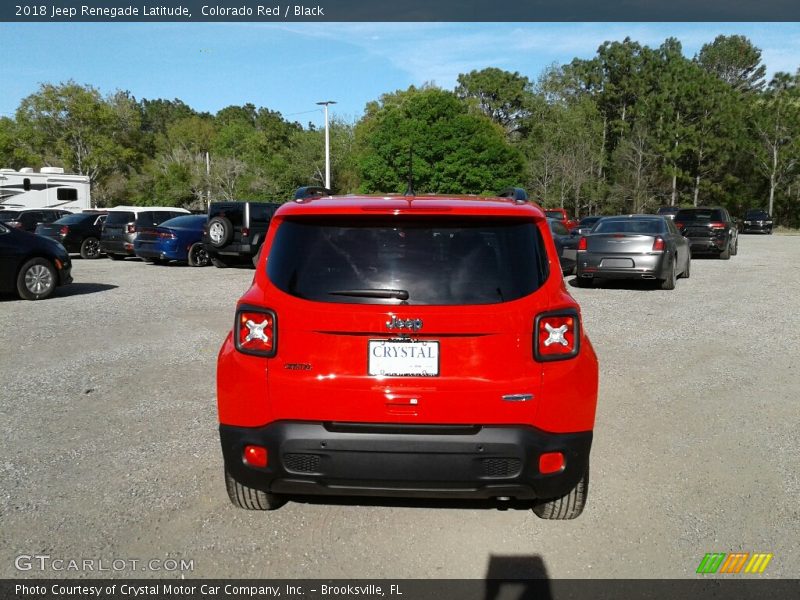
369 340 439 377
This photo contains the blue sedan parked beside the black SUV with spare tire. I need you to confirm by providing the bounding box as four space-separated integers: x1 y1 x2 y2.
133 215 209 267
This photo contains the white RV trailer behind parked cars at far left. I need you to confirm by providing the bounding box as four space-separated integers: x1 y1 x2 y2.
0 167 92 212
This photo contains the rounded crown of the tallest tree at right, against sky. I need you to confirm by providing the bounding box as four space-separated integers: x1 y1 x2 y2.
696 35 767 92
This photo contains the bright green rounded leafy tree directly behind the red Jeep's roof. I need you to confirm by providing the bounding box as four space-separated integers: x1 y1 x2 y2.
356 88 522 193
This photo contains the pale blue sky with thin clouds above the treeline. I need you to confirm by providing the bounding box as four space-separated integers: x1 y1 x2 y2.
0 23 800 125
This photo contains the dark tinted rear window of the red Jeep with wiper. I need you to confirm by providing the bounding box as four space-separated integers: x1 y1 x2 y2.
267 218 548 305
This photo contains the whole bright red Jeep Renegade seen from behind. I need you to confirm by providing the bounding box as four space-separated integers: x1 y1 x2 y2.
217 190 597 519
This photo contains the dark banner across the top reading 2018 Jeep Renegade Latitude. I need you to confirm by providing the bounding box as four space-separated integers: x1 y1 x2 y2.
0 0 800 23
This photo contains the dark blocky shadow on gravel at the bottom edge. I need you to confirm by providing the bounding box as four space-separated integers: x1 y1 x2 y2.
484 554 553 600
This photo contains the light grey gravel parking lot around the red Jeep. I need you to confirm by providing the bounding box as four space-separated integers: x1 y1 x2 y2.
0 236 800 578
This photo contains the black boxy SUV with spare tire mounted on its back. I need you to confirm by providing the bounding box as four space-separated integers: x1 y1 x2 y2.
203 202 281 267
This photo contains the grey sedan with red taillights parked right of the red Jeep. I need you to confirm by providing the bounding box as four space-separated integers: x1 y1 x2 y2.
575 215 691 290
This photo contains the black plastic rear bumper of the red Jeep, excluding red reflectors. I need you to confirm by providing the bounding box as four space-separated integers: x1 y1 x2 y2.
220 421 592 499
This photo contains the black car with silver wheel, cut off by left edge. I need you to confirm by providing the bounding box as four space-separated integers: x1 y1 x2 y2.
0 223 72 300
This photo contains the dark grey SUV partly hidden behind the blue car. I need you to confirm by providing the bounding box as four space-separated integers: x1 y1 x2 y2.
100 206 189 260
